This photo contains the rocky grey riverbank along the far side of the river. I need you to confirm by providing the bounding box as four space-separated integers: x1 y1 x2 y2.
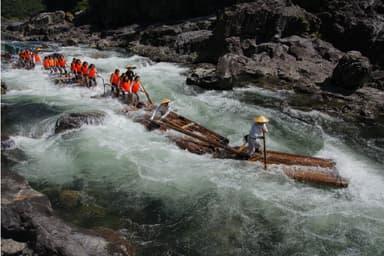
2 0 384 125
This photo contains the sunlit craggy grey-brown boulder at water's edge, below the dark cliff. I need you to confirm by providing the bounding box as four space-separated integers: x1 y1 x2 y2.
187 36 342 89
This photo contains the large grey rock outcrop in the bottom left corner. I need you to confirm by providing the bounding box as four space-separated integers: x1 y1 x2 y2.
1 169 135 256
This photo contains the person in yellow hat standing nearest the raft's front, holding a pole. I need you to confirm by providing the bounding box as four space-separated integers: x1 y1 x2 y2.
247 116 269 156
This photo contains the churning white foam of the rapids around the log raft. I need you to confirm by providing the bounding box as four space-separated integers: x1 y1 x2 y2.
2 47 384 254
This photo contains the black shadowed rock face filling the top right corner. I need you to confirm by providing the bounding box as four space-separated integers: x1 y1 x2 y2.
292 0 384 67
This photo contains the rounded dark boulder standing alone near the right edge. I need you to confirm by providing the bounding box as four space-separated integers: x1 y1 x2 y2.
331 51 371 90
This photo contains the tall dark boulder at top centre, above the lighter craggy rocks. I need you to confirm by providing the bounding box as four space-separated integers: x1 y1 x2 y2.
214 0 320 55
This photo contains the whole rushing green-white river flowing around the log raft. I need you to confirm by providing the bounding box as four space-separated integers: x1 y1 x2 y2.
1 43 384 255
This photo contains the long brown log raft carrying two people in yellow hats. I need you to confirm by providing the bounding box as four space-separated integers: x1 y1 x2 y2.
44 72 349 188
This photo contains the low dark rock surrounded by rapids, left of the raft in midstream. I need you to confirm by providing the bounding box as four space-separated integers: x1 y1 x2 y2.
55 112 105 134
